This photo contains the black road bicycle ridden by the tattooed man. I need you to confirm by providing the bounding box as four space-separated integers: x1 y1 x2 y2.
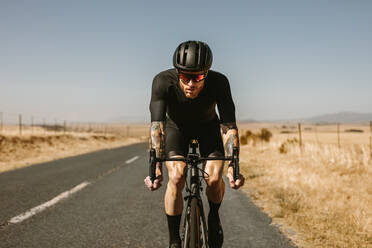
149 140 239 248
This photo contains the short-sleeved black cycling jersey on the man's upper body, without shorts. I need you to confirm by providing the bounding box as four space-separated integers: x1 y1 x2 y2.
150 69 235 126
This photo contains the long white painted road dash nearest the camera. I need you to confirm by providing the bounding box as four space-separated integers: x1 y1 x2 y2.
8 182 90 224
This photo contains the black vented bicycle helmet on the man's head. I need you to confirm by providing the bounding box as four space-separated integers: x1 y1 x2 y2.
173 40 213 72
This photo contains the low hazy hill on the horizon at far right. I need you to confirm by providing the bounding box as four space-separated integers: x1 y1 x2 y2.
302 112 372 123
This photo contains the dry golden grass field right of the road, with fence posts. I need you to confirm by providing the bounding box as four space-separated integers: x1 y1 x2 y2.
239 124 372 248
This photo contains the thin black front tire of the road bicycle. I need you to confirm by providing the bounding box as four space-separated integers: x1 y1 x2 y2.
189 197 201 248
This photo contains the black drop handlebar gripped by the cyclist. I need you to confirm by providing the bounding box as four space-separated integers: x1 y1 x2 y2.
149 147 240 182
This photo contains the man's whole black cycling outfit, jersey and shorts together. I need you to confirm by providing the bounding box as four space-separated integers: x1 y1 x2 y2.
150 69 235 157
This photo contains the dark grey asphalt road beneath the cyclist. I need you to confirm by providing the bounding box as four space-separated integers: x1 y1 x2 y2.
0 144 293 248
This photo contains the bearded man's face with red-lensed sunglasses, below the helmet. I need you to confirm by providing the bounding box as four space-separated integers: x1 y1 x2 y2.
179 71 206 99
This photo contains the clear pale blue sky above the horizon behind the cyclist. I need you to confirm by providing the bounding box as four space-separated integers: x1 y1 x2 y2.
0 0 372 121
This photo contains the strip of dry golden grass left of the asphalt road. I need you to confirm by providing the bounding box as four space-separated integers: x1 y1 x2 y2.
0 124 148 173
